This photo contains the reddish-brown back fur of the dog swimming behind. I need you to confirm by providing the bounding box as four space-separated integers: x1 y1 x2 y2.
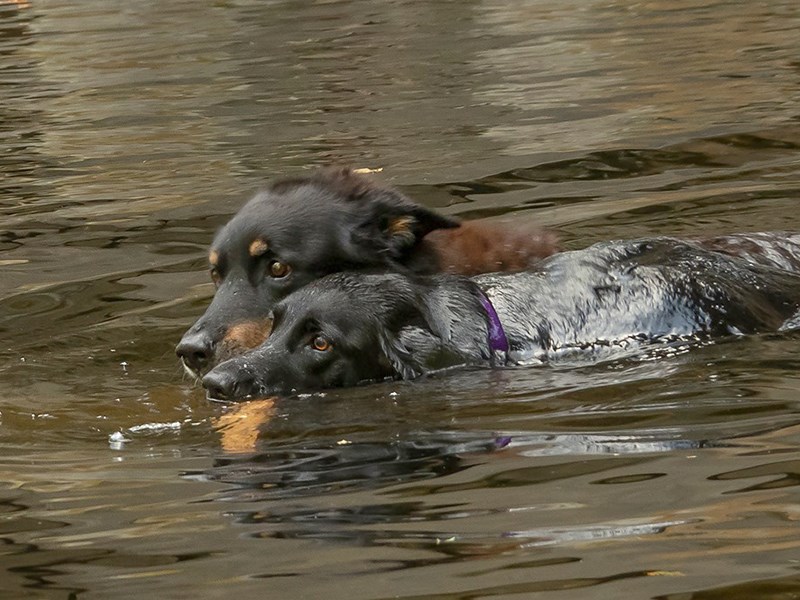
425 221 559 275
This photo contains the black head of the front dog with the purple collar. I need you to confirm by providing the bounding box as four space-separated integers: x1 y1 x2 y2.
203 273 463 401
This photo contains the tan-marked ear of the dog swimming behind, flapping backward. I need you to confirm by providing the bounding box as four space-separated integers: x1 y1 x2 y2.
353 187 460 260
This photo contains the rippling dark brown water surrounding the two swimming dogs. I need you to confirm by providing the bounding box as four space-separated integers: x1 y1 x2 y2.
0 0 800 600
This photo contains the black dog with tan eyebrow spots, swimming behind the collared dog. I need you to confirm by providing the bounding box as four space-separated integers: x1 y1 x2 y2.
176 169 556 375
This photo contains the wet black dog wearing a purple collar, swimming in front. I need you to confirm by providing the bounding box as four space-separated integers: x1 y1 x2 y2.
203 234 800 400
